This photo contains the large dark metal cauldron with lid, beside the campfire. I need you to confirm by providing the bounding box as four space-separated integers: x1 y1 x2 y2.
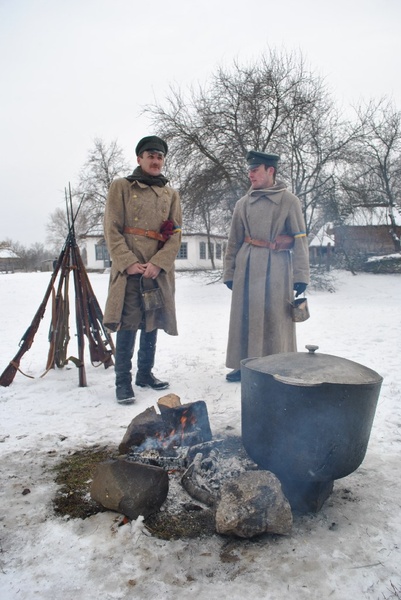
241 346 383 482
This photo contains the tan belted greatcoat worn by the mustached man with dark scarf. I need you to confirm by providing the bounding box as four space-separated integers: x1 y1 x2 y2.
103 178 181 335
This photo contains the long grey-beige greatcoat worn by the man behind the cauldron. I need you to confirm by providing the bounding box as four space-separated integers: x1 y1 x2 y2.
223 181 309 369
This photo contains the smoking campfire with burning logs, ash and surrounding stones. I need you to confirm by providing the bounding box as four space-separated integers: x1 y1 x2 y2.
91 394 292 537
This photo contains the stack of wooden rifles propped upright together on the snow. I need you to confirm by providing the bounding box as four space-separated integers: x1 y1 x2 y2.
0 187 114 387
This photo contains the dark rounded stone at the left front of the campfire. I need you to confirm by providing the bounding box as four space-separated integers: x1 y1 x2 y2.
90 459 169 519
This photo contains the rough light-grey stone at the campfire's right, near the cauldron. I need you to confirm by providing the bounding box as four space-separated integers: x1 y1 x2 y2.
216 470 292 538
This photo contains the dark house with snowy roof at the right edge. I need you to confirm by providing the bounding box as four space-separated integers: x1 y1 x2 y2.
333 206 401 255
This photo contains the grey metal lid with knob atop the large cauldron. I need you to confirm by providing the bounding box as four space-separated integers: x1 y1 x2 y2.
241 346 383 386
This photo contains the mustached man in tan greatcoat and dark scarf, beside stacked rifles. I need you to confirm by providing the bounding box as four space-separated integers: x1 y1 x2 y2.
104 136 181 404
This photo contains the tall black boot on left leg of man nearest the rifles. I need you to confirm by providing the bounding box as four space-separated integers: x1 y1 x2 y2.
114 329 136 404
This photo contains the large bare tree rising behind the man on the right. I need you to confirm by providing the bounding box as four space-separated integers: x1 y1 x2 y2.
145 51 344 236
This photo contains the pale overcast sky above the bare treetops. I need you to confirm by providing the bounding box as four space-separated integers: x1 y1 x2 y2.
0 0 401 246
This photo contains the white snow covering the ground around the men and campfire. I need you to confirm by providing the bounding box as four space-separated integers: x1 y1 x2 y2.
0 272 401 600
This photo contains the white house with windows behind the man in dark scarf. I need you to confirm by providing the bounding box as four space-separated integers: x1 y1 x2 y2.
84 226 227 271
